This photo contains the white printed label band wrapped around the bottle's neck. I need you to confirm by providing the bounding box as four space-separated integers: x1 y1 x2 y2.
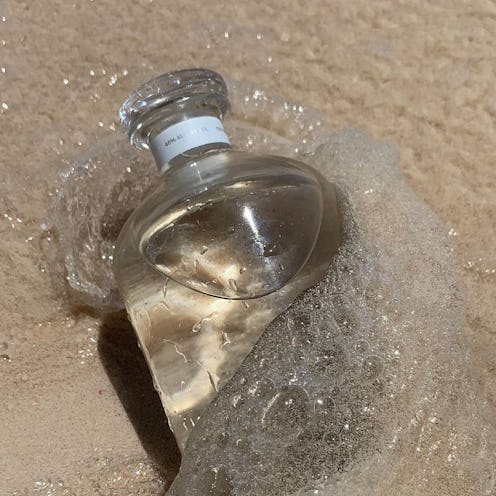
150 117 230 172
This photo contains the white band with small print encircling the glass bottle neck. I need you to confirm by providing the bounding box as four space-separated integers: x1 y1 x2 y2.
148 115 230 173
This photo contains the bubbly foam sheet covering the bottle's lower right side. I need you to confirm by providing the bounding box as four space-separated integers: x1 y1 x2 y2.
170 131 494 496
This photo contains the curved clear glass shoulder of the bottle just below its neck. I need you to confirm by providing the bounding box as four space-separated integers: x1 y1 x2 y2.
118 149 321 256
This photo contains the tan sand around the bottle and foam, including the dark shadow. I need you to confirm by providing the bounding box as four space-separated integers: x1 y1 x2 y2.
0 0 496 496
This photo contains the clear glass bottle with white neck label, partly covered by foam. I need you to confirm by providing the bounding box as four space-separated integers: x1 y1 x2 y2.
114 69 338 449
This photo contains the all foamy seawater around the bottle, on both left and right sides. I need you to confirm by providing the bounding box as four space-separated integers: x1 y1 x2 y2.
47 84 495 496
